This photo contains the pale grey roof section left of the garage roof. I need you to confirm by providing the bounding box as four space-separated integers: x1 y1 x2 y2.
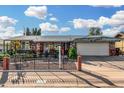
6 35 83 42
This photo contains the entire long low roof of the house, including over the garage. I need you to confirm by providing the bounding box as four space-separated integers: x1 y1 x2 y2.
6 35 120 42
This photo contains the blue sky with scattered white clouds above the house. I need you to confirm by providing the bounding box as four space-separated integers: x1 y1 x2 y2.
0 5 124 37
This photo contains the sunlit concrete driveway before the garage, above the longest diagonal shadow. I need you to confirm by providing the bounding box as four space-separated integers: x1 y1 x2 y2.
82 59 124 87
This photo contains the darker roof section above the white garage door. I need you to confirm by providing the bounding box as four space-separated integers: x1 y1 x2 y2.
74 36 120 42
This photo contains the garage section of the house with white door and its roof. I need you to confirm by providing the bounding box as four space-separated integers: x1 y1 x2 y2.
74 36 119 56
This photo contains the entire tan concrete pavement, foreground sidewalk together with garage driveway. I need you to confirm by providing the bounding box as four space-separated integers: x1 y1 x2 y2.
0 57 124 88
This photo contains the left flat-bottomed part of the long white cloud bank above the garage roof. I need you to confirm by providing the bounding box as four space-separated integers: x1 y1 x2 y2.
73 18 102 29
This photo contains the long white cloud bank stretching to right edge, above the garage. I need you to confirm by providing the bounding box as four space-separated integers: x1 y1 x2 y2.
73 10 124 29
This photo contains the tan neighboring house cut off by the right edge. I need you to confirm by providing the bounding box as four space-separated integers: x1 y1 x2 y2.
115 32 124 53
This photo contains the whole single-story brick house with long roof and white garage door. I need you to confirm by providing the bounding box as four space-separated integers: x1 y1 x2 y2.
5 36 119 56
